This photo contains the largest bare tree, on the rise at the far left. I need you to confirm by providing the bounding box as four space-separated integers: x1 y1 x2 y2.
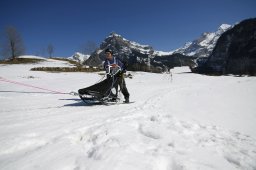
2 26 25 60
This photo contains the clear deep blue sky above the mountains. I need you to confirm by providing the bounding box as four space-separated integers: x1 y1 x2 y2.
0 0 256 57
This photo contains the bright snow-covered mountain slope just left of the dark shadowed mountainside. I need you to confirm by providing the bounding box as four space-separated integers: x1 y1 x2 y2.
174 24 232 57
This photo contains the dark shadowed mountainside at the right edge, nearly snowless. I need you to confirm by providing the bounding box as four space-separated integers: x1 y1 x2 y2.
194 18 256 76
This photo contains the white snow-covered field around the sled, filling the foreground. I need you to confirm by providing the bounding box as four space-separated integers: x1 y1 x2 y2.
0 57 256 170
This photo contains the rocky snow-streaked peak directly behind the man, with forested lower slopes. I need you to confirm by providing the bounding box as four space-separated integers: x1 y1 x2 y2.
85 33 193 72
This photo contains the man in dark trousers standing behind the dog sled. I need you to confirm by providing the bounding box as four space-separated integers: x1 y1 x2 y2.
104 49 130 103
